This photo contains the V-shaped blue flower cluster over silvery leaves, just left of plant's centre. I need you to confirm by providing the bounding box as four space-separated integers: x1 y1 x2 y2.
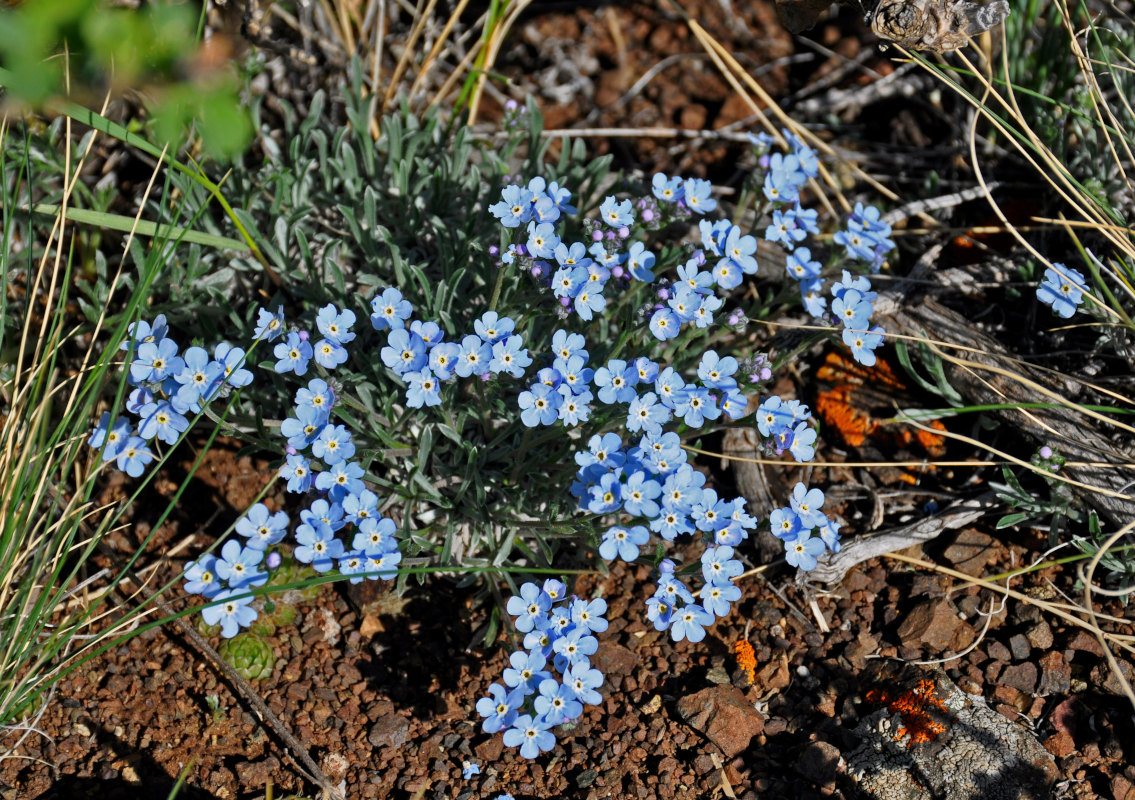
370 288 533 409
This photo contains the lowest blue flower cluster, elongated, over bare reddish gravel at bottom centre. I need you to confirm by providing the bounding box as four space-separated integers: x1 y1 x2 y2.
477 580 607 758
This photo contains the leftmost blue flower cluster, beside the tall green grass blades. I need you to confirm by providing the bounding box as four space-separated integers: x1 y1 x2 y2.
87 314 252 478
